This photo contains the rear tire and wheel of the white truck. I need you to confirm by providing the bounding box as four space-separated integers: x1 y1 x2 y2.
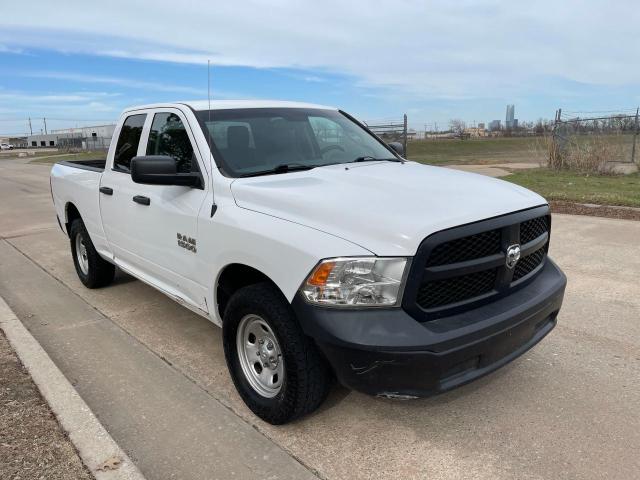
69 218 116 288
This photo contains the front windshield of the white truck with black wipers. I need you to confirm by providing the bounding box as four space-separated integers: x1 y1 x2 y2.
196 108 398 177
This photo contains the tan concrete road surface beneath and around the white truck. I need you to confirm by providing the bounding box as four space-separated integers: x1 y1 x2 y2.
0 156 640 480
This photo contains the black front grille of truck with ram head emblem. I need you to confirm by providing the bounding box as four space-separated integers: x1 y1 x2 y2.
403 206 551 320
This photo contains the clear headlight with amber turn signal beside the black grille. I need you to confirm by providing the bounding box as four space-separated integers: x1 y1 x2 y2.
300 257 407 307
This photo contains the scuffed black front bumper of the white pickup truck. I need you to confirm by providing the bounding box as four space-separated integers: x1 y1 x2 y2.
293 259 566 396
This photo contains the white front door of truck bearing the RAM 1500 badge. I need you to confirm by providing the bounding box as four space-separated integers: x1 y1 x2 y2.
104 109 209 311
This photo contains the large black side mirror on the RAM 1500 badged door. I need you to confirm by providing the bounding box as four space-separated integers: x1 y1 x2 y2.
131 155 203 188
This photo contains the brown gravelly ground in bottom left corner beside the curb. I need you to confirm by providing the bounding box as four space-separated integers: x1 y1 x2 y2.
0 330 93 480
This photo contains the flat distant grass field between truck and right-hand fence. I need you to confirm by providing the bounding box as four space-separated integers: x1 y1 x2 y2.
407 137 546 165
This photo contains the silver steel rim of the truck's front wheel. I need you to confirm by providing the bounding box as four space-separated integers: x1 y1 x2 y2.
236 314 284 398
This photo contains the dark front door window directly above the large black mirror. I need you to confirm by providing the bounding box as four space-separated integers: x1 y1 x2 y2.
147 113 198 173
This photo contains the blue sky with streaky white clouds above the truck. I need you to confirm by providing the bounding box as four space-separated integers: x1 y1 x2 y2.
0 0 640 134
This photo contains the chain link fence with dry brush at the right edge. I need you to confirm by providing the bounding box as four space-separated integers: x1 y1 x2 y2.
548 109 640 173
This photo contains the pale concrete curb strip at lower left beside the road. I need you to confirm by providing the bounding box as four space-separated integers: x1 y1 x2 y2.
0 297 145 480
